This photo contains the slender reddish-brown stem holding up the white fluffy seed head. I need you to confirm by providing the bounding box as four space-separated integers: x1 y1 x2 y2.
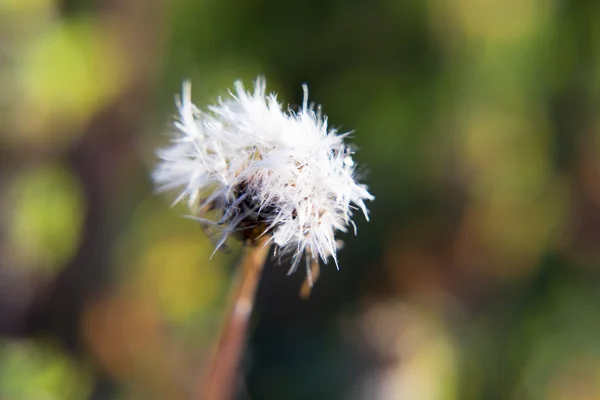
198 235 270 400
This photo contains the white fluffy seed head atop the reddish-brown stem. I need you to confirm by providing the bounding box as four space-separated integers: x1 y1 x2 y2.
153 78 373 272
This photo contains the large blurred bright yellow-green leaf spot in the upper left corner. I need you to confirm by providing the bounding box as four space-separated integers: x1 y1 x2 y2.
12 18 127 145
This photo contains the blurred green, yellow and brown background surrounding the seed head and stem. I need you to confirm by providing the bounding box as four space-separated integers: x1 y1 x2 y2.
0 0 600 400
